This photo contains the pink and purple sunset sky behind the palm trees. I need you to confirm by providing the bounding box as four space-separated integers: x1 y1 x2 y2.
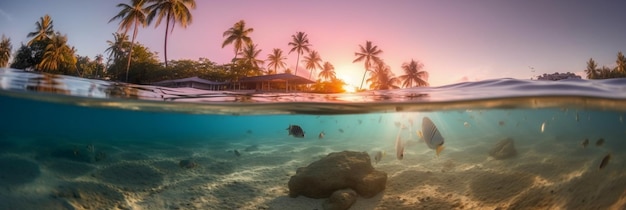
0 0 626 86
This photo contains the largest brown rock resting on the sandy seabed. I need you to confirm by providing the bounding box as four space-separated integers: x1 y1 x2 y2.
288 151 387 198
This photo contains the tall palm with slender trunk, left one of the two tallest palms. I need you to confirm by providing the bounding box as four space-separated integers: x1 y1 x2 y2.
109 0 149 82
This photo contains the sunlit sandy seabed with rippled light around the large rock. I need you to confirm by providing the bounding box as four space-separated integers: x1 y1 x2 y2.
0 136 626 210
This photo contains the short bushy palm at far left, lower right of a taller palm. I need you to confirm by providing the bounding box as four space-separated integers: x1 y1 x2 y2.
37 34 76 71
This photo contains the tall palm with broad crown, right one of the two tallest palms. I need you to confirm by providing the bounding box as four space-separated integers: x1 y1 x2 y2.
146 0 196 68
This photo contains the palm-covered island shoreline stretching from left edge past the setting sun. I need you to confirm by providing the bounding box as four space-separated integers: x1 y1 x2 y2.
0 0 429 93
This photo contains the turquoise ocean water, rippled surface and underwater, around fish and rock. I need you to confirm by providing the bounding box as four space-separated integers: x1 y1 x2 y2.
0 69 626 209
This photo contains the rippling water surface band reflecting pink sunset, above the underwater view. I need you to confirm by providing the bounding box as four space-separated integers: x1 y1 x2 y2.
0 69 626 114
